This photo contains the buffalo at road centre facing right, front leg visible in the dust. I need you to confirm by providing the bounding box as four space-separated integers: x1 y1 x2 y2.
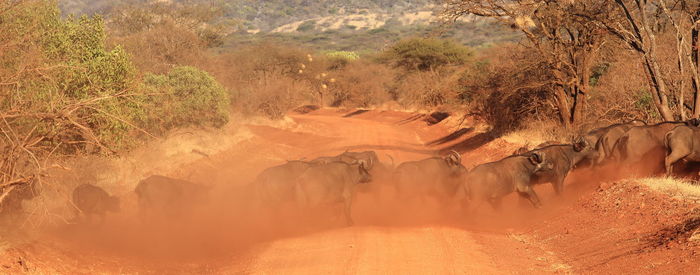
295 160 372 225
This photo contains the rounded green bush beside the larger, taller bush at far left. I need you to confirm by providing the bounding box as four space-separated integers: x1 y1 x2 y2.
144 66 230 132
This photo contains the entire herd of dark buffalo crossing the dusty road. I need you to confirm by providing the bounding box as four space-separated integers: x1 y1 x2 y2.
9 119 700 225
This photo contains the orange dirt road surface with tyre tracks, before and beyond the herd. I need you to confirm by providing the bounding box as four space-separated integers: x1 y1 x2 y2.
217 110 568 274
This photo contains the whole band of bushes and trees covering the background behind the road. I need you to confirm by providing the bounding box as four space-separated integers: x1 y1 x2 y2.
8 0 700 226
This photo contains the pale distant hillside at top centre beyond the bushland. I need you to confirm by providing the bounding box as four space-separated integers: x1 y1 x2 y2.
59 0 520 52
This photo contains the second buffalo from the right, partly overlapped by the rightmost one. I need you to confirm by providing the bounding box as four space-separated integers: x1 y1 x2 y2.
611 120 694 174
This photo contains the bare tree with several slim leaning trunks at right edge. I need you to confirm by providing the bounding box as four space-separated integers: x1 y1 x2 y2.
576 0 700 121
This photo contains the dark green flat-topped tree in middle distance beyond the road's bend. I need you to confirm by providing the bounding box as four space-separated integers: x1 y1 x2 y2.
379 38 473 71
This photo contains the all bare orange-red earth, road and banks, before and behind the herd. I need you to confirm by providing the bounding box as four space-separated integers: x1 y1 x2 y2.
0 110 700 274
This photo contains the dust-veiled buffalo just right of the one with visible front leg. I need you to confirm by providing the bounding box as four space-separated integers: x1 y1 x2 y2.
394 151 467 204
